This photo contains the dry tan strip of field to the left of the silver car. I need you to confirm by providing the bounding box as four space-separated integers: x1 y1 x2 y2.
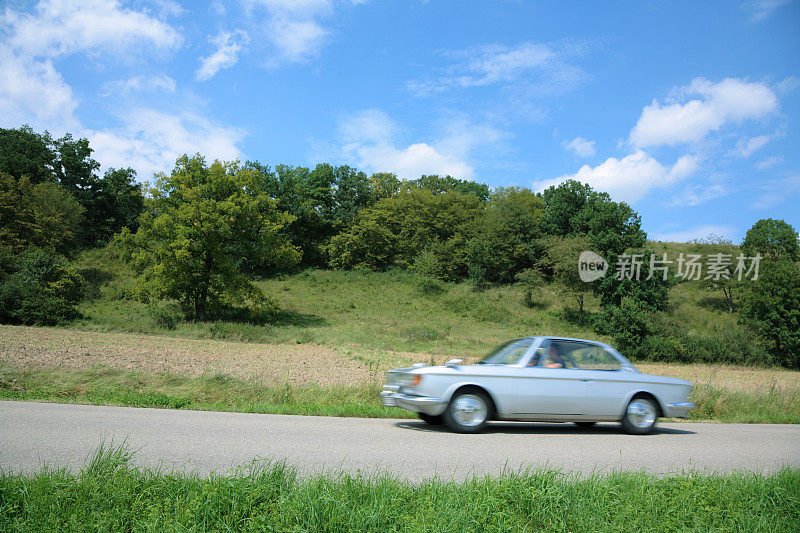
0 326 407 386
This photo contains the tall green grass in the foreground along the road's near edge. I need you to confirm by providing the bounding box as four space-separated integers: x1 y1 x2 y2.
0 447 800 532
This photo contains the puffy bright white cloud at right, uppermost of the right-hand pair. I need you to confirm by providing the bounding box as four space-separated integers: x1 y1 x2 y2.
630 78 778 147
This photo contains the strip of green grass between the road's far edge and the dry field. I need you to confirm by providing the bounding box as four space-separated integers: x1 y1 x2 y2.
0 366 800 424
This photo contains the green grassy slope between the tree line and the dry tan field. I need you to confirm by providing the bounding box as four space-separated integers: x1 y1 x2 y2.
68 243 768 364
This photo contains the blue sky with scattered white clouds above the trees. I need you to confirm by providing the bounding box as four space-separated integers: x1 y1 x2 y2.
0 0 800 241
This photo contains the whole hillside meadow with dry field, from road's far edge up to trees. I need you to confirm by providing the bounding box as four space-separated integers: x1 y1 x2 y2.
0 243 800 423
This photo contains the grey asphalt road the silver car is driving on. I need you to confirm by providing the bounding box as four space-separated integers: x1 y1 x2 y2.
0 401 800 480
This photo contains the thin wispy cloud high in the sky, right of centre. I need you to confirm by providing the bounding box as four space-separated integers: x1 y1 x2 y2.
407 42 587 96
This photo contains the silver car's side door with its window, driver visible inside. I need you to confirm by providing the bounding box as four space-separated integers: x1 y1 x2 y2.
515 339 587 419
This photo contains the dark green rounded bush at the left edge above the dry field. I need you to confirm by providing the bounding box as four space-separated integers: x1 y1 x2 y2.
0 249 84 325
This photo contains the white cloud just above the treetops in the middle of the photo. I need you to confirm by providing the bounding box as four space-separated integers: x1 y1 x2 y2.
336 110 502 179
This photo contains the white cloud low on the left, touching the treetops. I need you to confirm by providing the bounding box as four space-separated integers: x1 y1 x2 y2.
86 109 244 179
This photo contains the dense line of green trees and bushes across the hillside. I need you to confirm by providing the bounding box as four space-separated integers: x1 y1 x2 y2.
0 126 800 367
